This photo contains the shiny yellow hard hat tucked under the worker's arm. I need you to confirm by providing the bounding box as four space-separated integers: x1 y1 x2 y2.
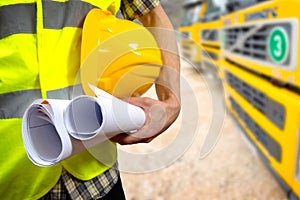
80 9 162 98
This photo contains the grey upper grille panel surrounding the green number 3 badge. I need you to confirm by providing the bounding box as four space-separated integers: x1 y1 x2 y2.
222 22 293 67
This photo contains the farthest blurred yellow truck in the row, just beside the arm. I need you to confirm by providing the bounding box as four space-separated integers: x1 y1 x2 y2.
179 0 202 67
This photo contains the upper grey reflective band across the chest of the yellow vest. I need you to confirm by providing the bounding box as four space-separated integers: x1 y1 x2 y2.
0 1 96 39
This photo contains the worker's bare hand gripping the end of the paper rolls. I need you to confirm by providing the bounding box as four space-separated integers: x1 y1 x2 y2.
111 97 180 145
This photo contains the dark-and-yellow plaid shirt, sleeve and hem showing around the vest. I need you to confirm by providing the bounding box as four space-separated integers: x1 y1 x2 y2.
41 0 160 200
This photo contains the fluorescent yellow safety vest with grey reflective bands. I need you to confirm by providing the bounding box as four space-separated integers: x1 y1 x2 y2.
0 0 120 199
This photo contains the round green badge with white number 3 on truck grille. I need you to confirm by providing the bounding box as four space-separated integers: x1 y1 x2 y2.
268 27 289 64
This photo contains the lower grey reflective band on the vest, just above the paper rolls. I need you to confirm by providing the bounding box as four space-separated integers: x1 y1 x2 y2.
0 85 83 119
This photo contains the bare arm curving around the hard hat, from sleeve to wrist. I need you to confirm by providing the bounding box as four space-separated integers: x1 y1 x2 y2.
139 6 180 106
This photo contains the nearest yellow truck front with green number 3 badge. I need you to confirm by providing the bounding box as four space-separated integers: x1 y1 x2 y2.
220 0 300 199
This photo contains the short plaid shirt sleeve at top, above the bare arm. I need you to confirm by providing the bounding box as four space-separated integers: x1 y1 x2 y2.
120 0 160 20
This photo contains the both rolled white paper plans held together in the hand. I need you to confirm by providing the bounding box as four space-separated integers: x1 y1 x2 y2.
22 88 145 166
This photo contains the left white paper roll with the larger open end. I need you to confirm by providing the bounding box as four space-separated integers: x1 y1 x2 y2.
22 99 72 166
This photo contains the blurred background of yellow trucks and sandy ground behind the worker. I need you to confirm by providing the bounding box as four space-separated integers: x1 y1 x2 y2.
119 0 300 200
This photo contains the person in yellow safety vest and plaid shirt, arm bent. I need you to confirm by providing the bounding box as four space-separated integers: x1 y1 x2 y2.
0 0 180 199
